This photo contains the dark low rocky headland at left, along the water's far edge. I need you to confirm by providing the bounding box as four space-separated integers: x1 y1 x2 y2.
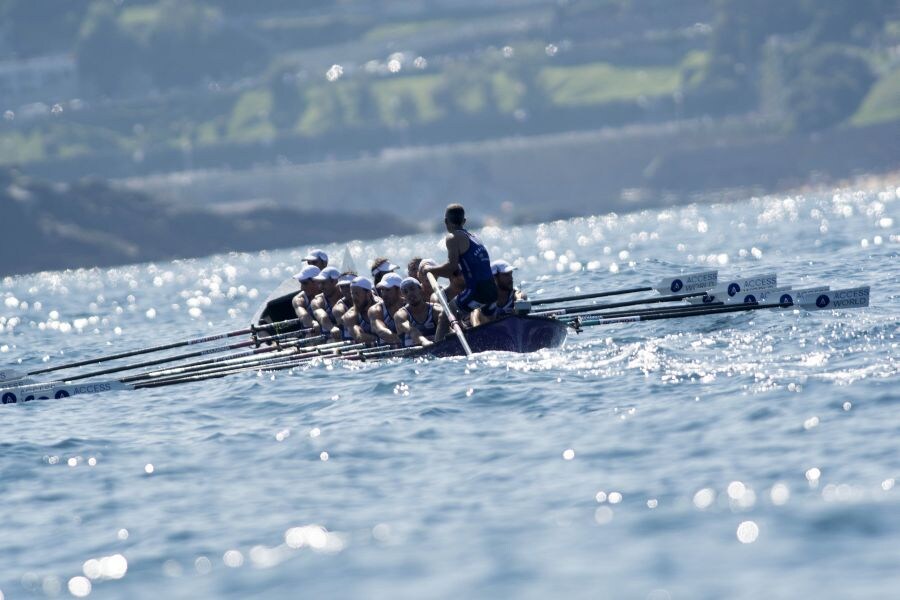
0 170 414 276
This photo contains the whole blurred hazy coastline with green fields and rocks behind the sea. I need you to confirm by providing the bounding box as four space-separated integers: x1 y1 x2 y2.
0 0 900 275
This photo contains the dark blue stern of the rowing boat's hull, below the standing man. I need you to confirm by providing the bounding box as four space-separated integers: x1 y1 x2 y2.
425 315 566 356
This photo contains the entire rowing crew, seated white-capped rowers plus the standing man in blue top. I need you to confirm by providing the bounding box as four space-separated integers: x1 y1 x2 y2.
292 204 525 347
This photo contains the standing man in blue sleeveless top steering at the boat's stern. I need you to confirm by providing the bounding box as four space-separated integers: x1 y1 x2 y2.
425 204 497 341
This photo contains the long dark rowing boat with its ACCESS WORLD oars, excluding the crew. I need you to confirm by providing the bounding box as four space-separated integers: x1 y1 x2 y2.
0 271 870 404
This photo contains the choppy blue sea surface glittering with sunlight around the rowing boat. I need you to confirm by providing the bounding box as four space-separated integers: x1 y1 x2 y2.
0 188 900 600
